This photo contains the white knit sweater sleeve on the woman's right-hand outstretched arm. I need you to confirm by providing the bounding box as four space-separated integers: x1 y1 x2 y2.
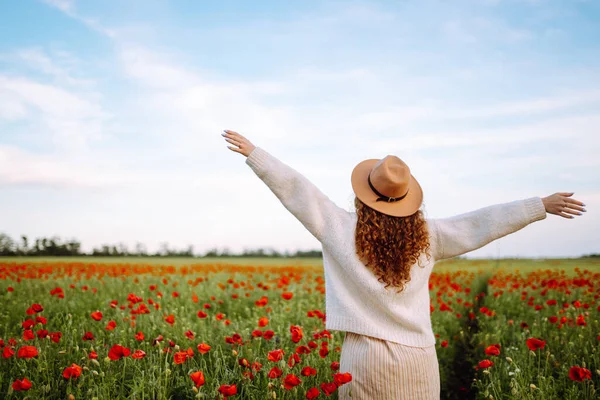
429 197 546 260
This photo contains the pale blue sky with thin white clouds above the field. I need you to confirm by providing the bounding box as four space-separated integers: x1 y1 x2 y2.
0 0 600 258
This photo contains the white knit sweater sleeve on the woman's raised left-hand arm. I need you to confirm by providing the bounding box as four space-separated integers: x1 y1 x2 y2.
246 147 348 242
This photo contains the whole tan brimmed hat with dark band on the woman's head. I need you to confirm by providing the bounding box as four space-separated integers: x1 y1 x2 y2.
352 155 423 217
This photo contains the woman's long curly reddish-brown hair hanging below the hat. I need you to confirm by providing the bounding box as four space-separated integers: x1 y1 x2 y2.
354 197 430 293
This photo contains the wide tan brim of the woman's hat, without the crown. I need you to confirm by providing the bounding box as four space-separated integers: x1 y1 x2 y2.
351 159 423 217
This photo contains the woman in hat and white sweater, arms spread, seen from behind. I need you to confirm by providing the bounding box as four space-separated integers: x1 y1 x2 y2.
222 130 585 400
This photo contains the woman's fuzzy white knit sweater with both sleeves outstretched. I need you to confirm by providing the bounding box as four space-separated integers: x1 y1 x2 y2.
246 147 546 347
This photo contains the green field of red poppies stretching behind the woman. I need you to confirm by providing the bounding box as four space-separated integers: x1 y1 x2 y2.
0 258 600 400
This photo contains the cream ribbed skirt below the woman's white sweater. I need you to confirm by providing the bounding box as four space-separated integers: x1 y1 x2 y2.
339 332 440 400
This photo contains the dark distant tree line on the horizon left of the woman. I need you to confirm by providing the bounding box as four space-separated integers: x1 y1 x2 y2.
0 233 323 258
